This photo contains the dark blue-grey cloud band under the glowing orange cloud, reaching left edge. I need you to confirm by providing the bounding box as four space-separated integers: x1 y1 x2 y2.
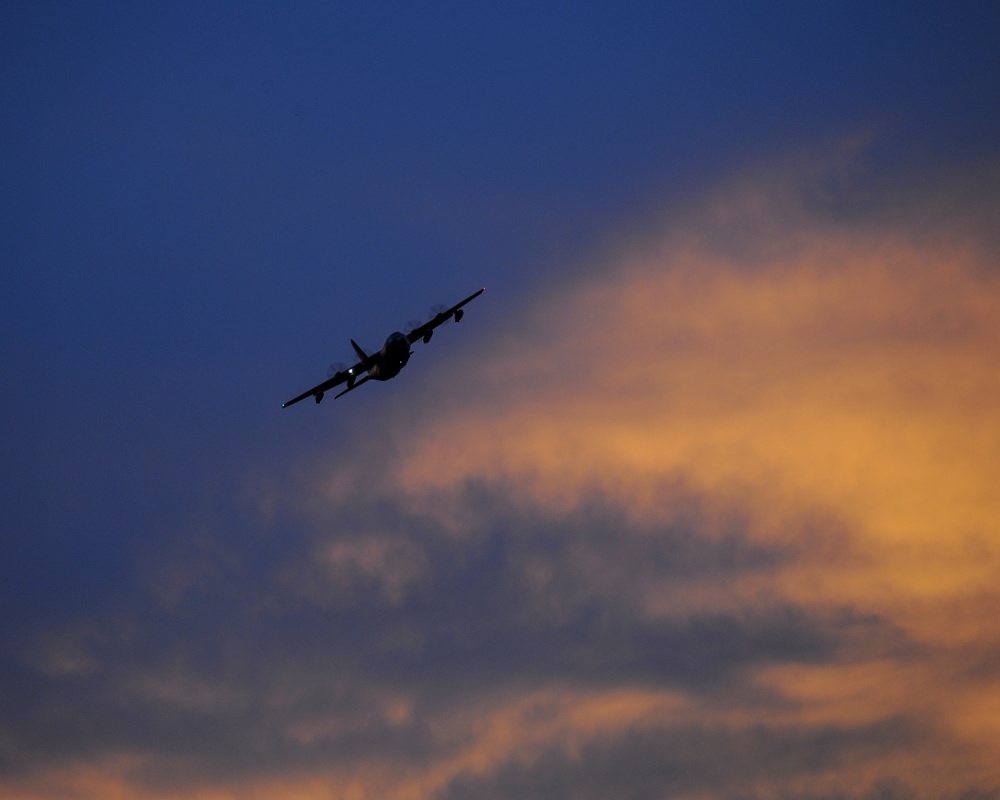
2 483 894 792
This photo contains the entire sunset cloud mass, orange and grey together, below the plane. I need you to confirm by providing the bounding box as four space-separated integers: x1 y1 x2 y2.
0 147 1000 798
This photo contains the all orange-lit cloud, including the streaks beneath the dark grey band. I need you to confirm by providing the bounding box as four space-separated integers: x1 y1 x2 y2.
227 153 1000 797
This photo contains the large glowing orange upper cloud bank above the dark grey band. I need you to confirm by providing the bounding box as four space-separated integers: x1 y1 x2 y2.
397 166 1000 596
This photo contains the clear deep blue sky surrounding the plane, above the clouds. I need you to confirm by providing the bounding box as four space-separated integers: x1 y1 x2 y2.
0 2 1000 792
